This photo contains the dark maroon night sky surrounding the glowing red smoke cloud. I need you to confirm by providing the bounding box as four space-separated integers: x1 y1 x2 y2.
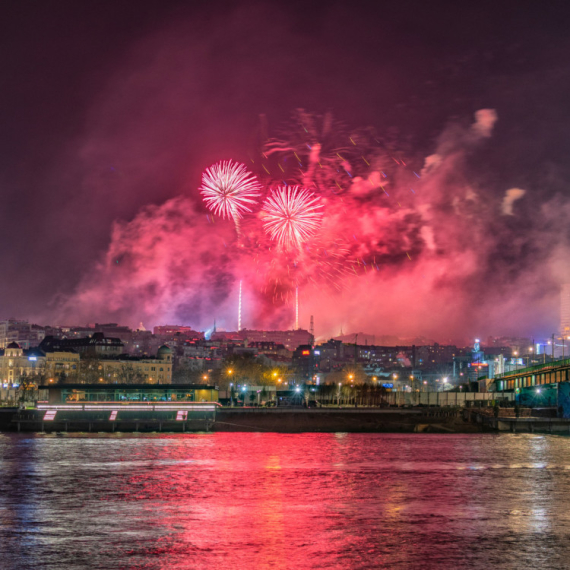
0 0 570 339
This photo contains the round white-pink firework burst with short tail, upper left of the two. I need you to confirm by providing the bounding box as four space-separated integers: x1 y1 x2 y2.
200 160 261 234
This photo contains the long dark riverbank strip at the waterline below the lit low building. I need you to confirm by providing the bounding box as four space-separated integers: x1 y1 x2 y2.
0 408 487 433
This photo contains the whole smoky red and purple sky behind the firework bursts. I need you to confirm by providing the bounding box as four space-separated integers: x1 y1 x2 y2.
0 1 570 341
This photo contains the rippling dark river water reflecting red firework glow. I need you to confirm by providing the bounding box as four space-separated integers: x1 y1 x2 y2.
0 433 570 570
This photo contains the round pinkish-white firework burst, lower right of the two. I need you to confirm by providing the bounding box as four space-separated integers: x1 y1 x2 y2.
262 186 322 249
